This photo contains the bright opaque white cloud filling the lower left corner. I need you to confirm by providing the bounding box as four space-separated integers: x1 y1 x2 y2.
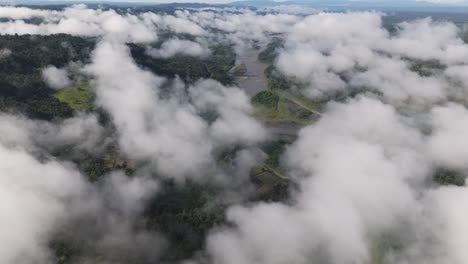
0 145 85 264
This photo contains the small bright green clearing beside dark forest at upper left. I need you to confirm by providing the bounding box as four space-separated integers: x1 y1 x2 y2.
54 82 94 111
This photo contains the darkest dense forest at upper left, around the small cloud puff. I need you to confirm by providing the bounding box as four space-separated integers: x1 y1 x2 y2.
0 34 94 120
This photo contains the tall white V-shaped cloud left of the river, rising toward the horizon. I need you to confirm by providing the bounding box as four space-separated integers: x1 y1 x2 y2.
85 42 266 182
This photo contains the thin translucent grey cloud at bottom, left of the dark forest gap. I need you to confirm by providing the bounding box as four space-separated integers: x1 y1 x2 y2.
55 172 166 263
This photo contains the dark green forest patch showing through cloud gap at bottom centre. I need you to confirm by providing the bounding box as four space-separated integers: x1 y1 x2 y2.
146 183 225 261
